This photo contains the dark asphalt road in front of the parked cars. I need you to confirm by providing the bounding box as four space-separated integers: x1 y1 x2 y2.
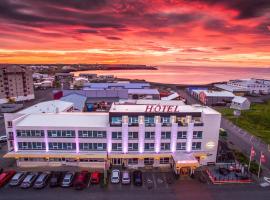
0 180 270 200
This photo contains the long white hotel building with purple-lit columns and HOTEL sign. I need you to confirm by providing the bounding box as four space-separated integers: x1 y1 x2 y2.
5 101 221 173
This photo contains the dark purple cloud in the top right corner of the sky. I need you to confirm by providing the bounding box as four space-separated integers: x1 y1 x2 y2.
189 0 270 19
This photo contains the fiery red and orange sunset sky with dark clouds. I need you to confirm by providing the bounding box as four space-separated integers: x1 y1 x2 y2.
0 0 270 67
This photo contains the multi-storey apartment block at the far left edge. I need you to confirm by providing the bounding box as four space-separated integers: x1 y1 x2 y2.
0 65 35 103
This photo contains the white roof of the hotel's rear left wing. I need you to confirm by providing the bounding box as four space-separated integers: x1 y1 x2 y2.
18 100 73 114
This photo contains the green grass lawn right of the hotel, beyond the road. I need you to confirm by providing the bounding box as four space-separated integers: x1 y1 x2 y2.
217 101 270 144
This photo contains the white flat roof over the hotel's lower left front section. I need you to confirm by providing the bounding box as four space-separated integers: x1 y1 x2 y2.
17 112 109 128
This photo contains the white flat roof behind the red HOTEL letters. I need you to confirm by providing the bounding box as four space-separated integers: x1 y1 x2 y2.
109 103 219 114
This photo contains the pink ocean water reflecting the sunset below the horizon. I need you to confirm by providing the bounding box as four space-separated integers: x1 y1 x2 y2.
74 66 270 84
